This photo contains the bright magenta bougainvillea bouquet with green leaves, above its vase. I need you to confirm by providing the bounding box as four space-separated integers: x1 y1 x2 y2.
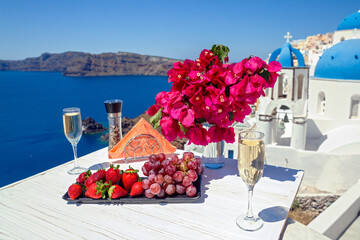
147 45 281 146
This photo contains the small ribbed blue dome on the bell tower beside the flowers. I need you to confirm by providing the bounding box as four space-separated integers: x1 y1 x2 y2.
269 42 305 67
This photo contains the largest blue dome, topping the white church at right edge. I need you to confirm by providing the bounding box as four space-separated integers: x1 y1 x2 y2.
314 39 360 80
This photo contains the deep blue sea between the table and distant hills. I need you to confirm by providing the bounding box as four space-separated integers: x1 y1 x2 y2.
0 71 171 187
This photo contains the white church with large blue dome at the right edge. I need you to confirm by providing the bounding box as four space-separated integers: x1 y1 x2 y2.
307 39 360 154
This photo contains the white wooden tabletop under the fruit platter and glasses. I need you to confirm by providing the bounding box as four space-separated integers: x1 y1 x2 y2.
0 148 326 239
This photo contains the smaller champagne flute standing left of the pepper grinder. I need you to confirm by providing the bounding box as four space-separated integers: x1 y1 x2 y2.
63 107 88 174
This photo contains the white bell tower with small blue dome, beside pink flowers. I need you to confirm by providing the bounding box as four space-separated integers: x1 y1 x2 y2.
256 42 309 149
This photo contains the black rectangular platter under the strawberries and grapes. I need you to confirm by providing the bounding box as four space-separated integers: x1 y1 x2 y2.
62 176 201 204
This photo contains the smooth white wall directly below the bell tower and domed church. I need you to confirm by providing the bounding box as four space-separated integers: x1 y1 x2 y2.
265 145 360 194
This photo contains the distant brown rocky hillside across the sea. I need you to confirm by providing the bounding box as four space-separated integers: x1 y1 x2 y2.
0 52 178 77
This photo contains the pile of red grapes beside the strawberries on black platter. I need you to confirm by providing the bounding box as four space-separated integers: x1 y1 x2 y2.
141 152 203 198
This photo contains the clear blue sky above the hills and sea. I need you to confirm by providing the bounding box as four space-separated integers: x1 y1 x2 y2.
0 0 360 61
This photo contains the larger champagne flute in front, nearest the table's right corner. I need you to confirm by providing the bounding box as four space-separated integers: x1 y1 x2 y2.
236 130 265 231
